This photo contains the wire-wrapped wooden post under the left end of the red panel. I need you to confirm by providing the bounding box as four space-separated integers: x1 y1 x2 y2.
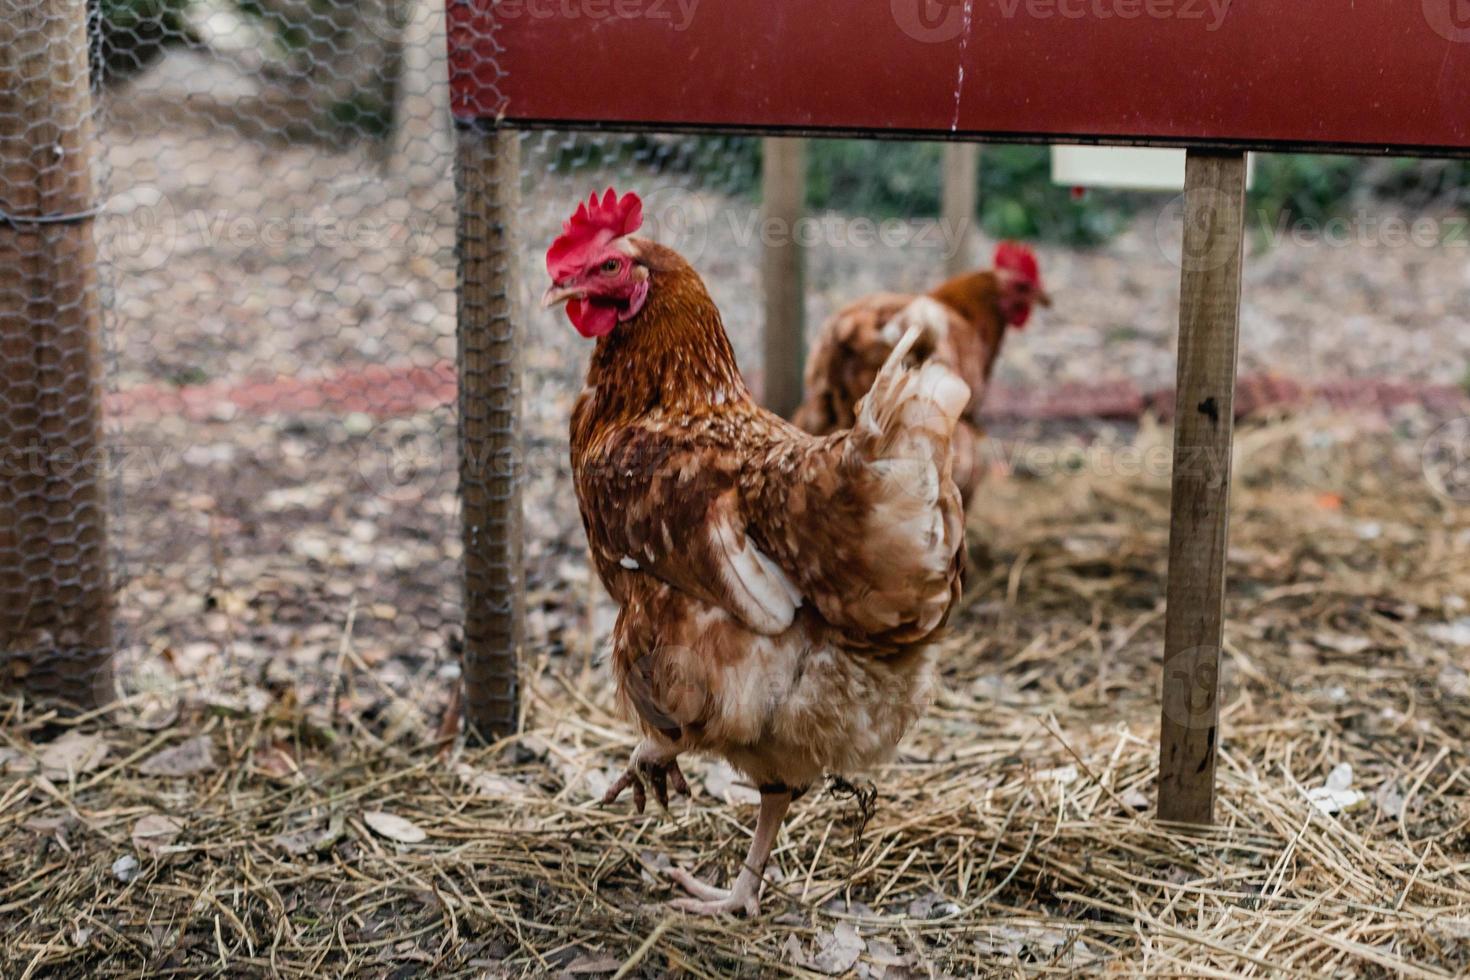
456 122 525 738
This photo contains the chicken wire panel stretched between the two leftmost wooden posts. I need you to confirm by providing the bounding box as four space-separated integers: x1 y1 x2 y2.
94 0 464 717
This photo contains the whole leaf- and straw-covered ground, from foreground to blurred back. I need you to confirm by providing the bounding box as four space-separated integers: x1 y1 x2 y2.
0 51 1470 977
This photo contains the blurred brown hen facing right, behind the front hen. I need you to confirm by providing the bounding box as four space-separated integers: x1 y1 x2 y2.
792 241 1051 507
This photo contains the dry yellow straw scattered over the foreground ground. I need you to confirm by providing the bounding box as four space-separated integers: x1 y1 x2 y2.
0 422 1470 979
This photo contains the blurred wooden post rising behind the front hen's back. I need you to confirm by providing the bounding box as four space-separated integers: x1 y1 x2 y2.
760 138 807 419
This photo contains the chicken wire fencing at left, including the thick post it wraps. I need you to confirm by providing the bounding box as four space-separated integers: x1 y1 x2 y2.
0 0 476 708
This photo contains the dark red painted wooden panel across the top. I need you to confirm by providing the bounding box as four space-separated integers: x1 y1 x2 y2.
447 0 1470 153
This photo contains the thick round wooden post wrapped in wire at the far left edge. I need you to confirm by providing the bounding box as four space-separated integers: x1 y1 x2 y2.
0 0 113 705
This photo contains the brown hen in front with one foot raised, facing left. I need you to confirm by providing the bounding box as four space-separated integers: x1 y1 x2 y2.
544 190 970 914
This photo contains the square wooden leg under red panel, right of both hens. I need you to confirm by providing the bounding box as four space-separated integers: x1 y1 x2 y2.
1158 150 1245 824
